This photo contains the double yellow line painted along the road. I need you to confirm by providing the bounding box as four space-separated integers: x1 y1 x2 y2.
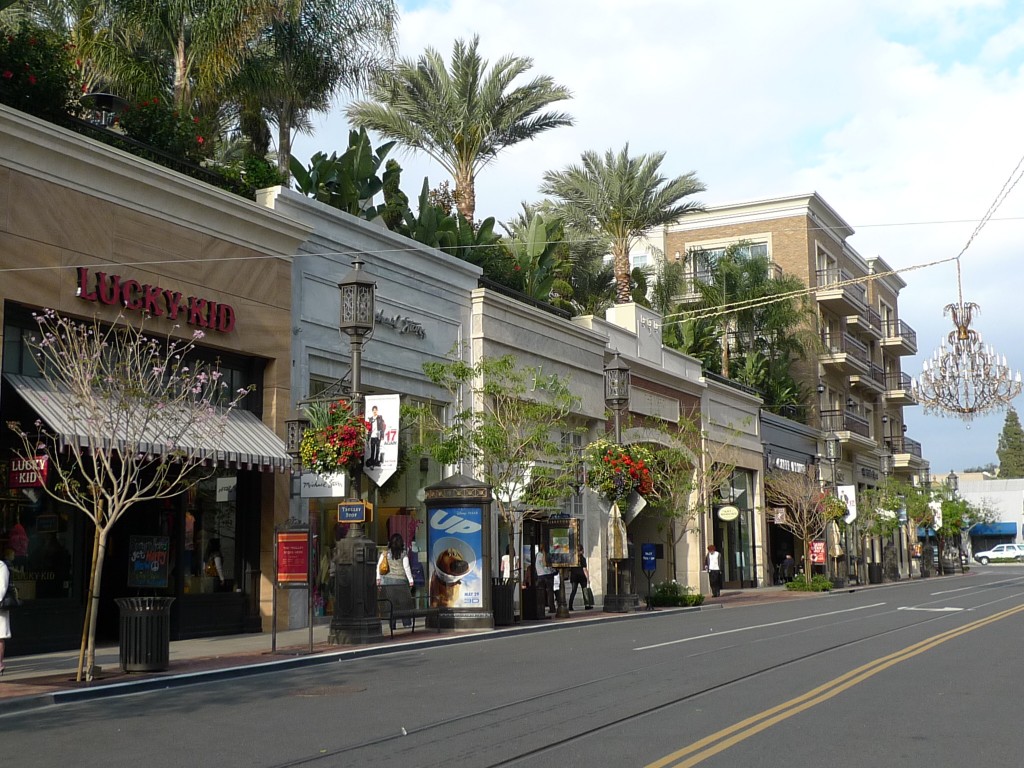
646 605 1024 768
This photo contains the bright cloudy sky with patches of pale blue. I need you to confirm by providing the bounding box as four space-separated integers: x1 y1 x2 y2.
296 0 1024 473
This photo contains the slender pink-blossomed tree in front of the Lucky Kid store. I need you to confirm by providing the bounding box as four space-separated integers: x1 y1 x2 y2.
7 310 245 680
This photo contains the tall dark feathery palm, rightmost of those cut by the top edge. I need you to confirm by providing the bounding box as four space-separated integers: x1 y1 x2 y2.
233 0 398 174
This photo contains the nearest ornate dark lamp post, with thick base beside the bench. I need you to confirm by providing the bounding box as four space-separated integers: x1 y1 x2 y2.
328 259 381 644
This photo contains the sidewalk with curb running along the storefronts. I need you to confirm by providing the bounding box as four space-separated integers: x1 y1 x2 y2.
0 587 816 716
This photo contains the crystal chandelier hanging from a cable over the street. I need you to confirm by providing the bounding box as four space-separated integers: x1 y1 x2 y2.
912 264 1021 421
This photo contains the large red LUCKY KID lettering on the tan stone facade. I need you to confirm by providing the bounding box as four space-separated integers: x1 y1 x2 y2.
78 266 234 334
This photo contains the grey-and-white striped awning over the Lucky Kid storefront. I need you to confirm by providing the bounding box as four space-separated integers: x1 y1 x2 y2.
4 374 292 470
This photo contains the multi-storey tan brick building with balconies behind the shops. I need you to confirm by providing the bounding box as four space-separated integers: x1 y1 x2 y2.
651 193 928 577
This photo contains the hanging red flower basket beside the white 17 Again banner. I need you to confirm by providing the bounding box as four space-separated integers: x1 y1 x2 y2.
299 400 369 475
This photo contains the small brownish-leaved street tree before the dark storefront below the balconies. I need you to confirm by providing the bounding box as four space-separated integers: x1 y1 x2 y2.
765 468 846 583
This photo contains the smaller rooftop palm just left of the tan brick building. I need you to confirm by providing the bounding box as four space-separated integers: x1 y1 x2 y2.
541 143 705 304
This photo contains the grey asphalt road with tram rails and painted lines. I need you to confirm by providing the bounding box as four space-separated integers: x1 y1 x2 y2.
0 566 1024 768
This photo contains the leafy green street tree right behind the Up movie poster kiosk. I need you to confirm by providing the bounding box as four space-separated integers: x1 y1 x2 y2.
413 353 579 622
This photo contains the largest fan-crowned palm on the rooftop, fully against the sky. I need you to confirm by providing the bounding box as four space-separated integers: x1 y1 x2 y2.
346 36 572 221
